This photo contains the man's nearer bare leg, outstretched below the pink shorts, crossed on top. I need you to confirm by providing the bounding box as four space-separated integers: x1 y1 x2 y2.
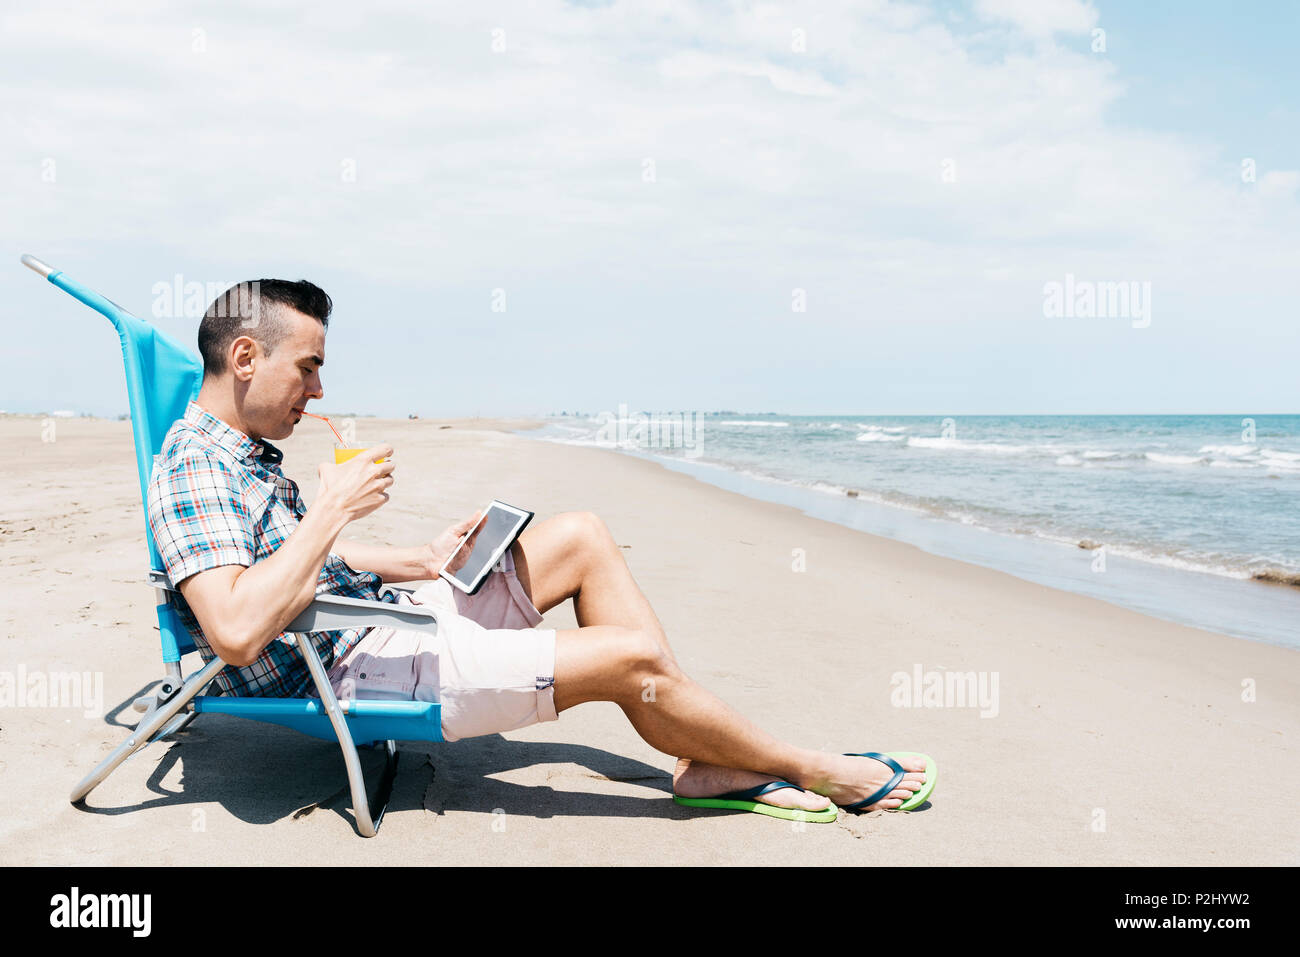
555 625 926 809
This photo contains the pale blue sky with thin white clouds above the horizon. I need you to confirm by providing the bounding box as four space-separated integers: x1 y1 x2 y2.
0 0 1300 416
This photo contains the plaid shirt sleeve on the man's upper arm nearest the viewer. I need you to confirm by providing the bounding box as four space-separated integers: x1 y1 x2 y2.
148 450 256 585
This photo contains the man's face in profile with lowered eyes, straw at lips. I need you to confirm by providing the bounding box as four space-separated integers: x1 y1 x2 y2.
243 306 325 438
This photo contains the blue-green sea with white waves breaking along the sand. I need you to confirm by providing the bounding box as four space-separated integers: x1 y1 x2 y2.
520 407 1300 649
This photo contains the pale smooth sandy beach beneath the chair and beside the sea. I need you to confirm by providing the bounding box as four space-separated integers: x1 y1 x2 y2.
0 416 1300 866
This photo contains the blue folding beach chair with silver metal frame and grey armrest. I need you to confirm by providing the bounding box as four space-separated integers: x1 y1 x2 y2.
22 256 442 837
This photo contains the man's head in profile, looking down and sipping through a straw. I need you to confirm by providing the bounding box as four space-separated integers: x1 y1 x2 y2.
199 280 334 439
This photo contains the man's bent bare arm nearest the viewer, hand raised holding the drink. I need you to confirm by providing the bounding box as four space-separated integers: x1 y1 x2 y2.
178 446 393 667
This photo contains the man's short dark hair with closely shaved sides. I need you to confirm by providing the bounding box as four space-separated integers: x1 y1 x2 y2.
199 280 334 378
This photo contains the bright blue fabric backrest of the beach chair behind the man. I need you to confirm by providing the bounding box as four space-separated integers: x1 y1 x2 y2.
23 257 203 662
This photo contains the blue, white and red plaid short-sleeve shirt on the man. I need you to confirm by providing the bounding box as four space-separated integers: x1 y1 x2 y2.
148 402 397 697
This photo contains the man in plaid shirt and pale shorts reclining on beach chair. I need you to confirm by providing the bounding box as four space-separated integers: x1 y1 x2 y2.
148 280 933 819
